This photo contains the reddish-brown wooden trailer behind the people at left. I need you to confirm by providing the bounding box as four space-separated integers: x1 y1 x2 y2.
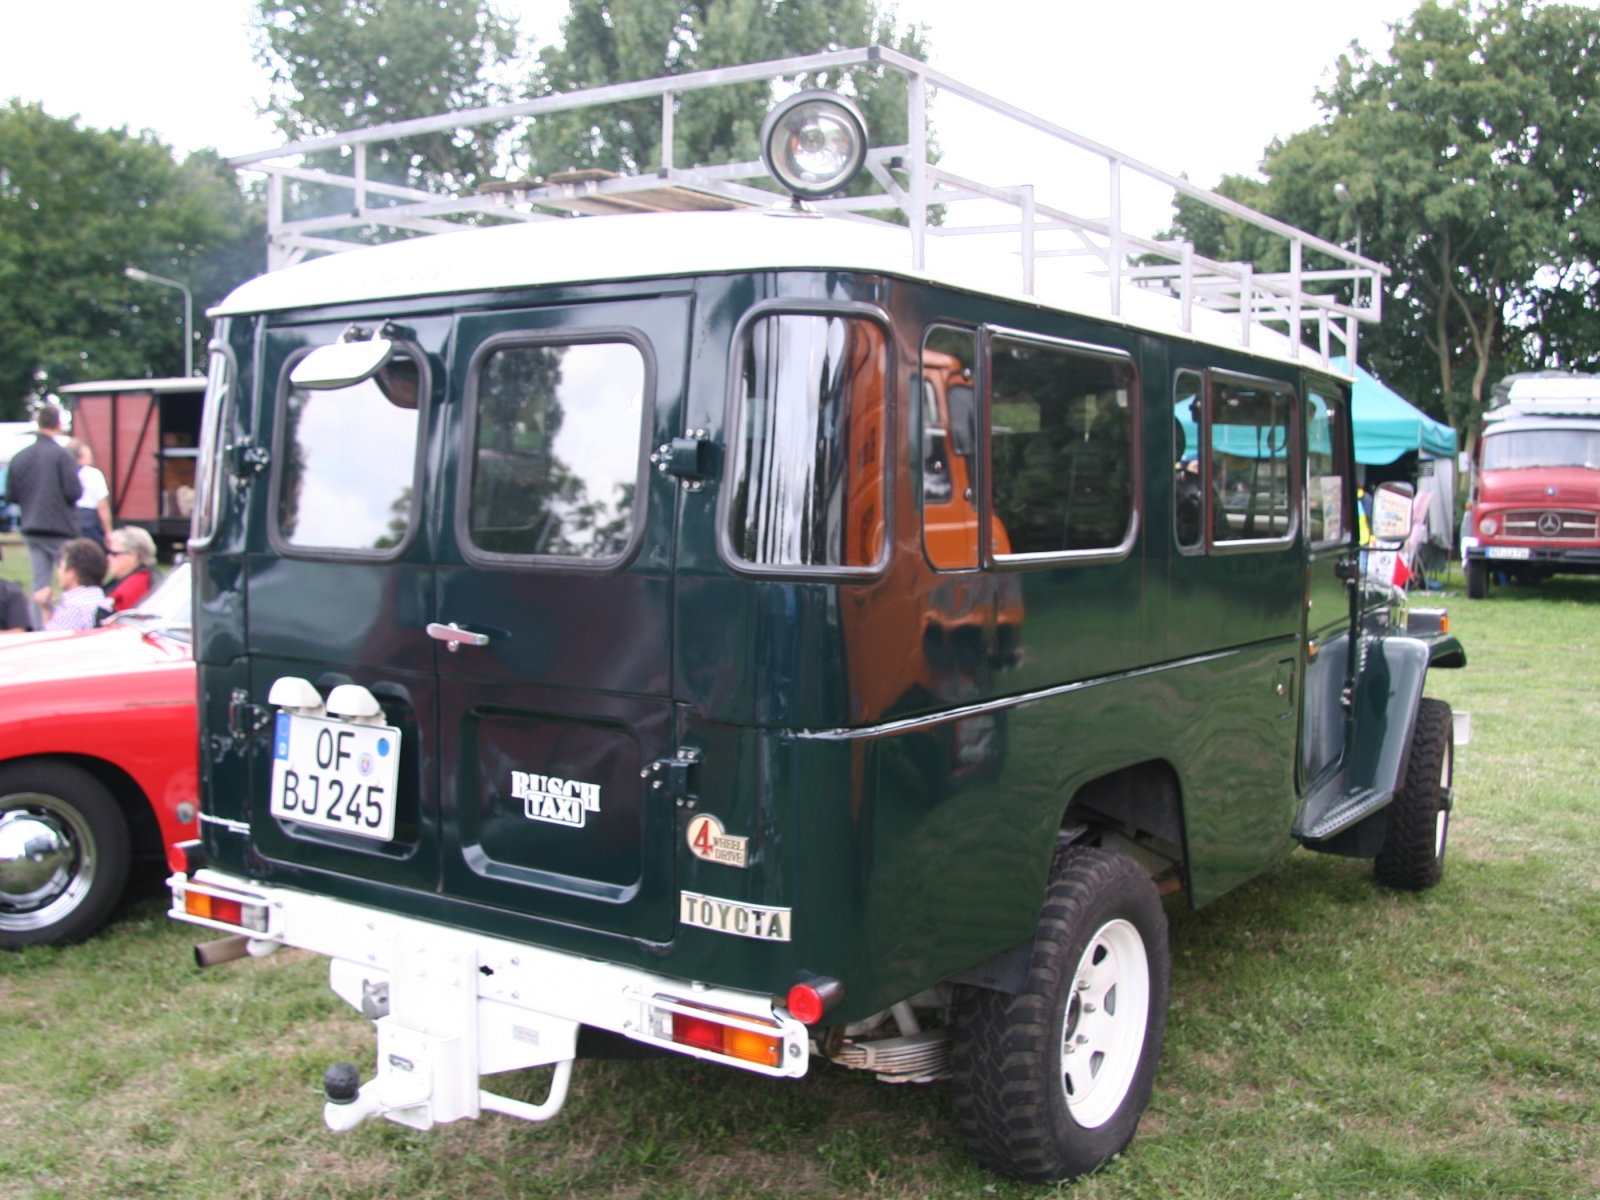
59 376 205 557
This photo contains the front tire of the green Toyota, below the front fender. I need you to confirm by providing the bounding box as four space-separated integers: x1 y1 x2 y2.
1373 698 1454 891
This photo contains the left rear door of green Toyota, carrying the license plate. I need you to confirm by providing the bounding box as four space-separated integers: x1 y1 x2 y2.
243 315 451 891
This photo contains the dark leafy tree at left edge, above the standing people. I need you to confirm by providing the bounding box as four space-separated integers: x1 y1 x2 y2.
0 101 262 419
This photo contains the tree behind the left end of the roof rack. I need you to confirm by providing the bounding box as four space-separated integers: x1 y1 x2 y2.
256 0 517 192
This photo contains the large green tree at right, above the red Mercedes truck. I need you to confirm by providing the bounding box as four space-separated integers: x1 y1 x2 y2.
1174 0 1600 445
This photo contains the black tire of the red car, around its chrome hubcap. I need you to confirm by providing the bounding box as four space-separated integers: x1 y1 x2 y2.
0 758 130 950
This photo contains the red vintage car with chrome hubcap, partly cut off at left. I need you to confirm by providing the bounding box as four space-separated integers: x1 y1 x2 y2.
0 566 198 949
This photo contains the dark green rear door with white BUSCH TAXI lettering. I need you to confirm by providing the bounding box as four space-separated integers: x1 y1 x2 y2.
435 294 690 941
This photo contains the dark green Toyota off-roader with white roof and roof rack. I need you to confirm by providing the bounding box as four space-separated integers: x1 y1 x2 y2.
171 51 1466 1179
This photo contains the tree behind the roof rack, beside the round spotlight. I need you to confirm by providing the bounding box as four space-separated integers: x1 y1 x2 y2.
523 0 926 188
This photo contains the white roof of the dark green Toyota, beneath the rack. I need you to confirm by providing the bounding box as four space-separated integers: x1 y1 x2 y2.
211 210 1338 374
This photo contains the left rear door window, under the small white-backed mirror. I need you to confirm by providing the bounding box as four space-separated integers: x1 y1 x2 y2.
275 354 426 552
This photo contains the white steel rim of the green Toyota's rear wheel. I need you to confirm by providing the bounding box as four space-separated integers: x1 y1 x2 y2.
1061 917 1150 1130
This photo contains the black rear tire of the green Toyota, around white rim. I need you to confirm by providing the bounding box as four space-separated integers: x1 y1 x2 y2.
950 846 1171 1182
